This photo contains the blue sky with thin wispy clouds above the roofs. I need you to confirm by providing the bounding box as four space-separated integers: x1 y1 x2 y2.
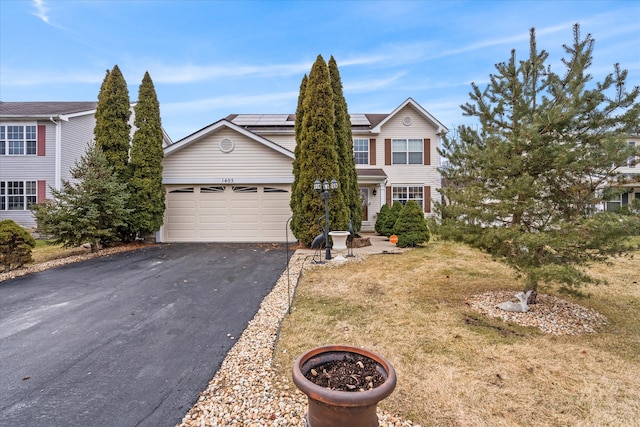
0 0 640 141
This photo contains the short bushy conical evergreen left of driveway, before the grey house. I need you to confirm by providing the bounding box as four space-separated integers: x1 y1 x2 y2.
32 145 130 252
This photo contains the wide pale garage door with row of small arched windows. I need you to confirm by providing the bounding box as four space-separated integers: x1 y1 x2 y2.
163 185 294 242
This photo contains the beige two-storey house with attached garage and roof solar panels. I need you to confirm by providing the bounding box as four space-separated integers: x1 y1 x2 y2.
158 98 447 242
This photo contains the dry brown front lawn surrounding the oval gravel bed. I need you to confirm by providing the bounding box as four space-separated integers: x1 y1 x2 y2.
274 242 640 426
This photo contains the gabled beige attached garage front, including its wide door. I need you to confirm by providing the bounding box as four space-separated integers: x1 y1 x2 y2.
158 120 295 242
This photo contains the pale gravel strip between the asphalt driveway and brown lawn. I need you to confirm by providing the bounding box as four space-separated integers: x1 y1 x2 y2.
178 253 419 427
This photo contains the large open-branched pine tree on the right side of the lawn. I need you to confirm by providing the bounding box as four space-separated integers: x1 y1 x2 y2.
438 25 640 302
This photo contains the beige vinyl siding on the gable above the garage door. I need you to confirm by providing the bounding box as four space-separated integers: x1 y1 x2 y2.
163 128 293 183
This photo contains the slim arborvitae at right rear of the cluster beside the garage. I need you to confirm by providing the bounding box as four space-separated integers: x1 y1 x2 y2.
329 56 362 232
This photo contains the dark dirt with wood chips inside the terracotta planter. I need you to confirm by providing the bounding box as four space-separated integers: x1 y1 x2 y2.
305 353 385 391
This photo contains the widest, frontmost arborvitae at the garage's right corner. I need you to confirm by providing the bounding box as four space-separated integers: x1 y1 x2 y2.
291 55 349 245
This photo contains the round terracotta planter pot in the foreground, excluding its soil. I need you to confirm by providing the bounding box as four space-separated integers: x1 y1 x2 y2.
292 345 396 427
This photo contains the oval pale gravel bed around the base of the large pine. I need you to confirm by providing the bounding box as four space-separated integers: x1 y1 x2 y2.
467 291 607 335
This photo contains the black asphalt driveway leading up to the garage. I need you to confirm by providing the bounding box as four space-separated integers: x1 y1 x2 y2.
0 244 286 427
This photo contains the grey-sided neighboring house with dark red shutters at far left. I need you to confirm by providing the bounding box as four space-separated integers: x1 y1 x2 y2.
0 101 171 227
